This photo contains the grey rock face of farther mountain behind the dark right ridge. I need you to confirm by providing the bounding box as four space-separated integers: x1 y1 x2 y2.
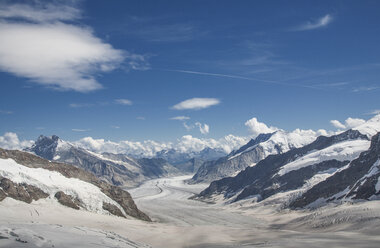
189 133 273 183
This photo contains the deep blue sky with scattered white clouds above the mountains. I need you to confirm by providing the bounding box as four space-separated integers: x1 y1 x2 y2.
0 0 380 141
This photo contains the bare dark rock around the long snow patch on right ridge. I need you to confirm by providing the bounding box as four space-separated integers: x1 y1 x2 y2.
198 130 368 201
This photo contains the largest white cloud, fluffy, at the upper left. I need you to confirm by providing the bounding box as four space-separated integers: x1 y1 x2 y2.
0 3 146 92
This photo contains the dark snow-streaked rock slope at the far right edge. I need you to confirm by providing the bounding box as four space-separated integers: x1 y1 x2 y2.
290 133 380 208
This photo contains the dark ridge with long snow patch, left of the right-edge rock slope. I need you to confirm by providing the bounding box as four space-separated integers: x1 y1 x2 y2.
199 130 370 204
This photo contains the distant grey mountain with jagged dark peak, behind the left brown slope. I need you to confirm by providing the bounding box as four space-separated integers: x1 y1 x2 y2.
27 135 178 187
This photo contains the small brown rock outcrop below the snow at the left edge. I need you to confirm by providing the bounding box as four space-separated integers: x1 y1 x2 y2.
0 177 49 203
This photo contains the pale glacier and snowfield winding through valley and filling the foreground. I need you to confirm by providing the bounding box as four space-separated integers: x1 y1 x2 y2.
0 176 380 248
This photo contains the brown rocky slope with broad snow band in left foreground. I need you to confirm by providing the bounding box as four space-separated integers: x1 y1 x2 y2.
0 148 150 221
